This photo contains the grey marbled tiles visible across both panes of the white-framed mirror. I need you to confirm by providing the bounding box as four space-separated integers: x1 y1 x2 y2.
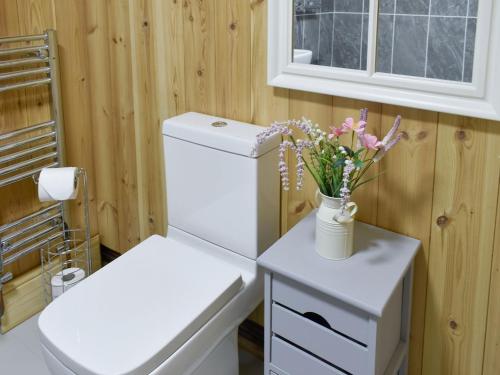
294 0 478 83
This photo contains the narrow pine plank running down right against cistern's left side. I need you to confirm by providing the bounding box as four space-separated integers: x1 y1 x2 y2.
129 0 167 239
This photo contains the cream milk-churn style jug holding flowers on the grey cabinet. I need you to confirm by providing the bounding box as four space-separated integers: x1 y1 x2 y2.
315 191 358 260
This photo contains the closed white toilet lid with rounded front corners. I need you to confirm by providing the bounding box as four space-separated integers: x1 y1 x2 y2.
39 236 242 375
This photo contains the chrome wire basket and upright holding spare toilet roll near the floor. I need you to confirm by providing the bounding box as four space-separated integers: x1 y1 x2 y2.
40 168 92 304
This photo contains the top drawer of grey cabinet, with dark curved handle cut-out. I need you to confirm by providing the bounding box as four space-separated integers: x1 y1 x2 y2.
272 275 368 345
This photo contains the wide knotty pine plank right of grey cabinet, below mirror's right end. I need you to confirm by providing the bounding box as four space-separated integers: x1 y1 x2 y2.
421 114 500 374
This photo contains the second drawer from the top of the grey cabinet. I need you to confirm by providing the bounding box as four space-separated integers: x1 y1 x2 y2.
271 303 368 374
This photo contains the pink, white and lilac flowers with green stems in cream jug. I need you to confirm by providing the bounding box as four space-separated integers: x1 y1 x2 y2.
257 109 402 214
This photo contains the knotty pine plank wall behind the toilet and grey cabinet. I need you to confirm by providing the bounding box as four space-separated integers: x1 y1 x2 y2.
0 0 500 375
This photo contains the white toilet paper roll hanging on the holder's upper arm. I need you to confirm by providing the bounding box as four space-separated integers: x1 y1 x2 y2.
38 167 78 202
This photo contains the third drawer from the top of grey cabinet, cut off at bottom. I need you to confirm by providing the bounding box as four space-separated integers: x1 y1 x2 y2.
271 337 345 375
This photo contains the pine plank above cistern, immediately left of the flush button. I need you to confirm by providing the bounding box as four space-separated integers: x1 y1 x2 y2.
183 0 217 114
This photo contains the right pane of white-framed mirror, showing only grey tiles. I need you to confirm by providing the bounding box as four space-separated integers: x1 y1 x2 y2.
376 0 478 82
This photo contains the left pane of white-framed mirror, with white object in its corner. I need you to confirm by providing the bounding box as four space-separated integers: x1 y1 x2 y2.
293 0 369 70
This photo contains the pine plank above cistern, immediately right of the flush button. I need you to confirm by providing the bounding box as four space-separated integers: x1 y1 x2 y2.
215 0 252 122
